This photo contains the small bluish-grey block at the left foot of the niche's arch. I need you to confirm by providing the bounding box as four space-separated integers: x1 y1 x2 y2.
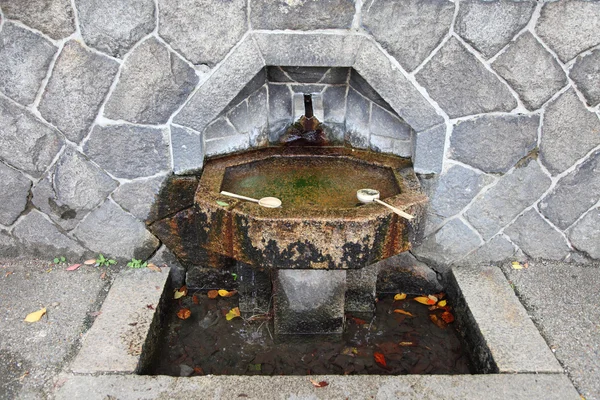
171 125 204 175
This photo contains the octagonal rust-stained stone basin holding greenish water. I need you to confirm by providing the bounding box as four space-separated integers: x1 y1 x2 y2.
194 147 427 269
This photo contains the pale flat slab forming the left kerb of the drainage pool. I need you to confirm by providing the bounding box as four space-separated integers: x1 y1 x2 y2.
69 268 170 374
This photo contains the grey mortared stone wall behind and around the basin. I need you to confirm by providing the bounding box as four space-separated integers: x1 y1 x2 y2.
0 0 600 269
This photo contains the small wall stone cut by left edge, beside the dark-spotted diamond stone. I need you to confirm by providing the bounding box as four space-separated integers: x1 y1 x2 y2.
0 163 31 226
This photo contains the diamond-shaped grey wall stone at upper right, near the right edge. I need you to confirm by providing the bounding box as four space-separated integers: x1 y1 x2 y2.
492 32 567 110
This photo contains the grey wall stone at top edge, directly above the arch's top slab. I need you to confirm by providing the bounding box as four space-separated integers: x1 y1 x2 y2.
250 0 355 30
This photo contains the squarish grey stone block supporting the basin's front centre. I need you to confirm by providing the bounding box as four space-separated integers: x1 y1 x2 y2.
273 269 346 335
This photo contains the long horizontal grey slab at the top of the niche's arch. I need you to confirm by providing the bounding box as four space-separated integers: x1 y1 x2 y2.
252 32 363 67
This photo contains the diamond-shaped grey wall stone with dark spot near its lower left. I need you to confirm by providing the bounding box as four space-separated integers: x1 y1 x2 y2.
32 148 118 230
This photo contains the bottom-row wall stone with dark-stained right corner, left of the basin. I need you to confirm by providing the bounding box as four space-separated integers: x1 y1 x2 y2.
73 200 160 261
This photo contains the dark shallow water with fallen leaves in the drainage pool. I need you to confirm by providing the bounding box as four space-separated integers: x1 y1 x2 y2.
145 293 471 376
